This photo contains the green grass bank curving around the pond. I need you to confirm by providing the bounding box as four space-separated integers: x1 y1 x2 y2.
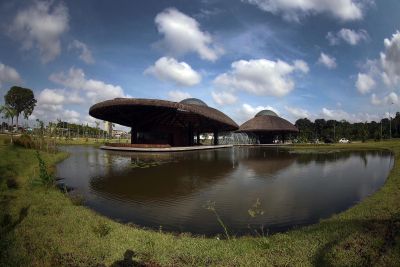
0 137 400 266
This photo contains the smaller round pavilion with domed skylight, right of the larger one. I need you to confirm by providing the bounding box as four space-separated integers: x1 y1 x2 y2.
238 110 299 144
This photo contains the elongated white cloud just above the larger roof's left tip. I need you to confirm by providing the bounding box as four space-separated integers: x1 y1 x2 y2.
49 68 125 103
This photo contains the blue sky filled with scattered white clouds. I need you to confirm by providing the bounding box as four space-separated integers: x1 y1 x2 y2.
0 0 400 130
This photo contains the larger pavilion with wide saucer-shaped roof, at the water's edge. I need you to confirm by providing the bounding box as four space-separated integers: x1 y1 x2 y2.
89 98 239 147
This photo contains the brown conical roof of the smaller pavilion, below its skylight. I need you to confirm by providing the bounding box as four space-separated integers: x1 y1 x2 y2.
239 115 299 132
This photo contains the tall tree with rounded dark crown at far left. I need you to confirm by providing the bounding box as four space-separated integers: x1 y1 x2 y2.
4 86 37 130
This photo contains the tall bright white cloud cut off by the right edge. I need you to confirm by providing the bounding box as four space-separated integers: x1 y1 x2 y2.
380 31 400 85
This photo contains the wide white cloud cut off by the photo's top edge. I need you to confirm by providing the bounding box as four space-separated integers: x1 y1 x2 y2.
242 0 371 21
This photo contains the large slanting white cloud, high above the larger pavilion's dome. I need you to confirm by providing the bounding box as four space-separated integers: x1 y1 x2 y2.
155 8 223 61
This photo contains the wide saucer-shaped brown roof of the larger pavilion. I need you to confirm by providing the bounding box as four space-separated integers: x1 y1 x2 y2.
89 98 239 131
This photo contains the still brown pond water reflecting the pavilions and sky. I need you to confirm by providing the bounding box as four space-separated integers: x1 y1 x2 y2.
57 146 394 235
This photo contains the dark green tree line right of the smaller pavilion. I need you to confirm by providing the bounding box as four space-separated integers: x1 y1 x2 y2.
295 115 400 142
